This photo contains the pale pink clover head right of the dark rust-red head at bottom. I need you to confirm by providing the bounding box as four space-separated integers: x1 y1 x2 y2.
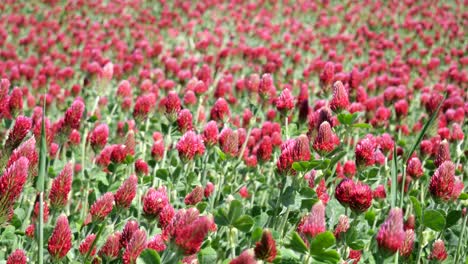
297 201 326 238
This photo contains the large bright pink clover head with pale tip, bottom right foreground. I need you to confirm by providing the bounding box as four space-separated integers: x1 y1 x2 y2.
376 208 405 254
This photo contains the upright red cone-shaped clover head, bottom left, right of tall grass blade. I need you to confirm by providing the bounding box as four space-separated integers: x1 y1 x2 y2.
47 215 72 259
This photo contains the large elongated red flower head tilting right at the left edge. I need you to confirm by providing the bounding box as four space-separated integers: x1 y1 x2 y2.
0 157 29 224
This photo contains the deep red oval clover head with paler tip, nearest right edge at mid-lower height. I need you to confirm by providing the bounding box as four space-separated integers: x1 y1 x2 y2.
429 161 455 202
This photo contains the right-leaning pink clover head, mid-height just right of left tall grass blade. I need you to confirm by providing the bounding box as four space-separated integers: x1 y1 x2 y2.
49 163 73 209
